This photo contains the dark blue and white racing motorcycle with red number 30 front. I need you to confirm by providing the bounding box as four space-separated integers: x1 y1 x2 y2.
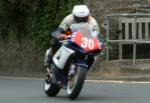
44 23 102 100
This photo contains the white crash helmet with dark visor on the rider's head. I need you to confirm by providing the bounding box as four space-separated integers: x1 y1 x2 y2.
72 5 90 23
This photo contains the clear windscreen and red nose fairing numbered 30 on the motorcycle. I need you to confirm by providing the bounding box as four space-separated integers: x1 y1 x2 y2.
70 23 101 52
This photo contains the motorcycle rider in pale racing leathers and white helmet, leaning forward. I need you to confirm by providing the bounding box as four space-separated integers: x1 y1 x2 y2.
44 5 104 68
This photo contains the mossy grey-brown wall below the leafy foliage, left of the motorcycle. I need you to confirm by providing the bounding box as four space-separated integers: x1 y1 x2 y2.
0 39 43 76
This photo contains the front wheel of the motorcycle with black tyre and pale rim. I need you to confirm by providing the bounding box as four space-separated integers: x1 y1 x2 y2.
67 66 87 100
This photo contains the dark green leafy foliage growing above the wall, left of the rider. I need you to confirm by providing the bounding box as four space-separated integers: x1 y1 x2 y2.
0 0 83 54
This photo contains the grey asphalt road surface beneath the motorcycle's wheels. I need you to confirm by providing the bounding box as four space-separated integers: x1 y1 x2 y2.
0 77 150 103
